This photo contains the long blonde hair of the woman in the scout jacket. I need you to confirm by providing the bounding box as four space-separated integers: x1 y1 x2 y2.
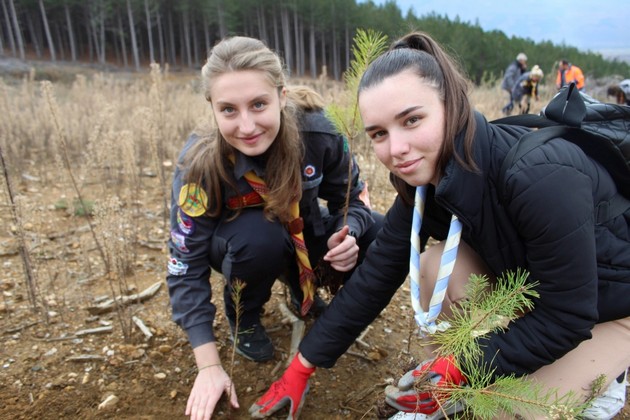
183 37 304 222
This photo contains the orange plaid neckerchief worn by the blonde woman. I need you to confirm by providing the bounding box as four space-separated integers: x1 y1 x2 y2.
239 167 315 316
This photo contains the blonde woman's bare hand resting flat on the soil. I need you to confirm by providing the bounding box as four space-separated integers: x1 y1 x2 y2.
186 364 239 420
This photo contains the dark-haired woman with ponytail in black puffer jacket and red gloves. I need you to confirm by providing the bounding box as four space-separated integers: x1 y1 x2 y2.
250 32 630 418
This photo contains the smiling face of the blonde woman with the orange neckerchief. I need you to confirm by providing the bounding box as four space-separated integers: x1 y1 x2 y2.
210 70 286 156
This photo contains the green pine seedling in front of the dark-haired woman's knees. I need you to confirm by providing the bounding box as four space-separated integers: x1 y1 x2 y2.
415 270 601 419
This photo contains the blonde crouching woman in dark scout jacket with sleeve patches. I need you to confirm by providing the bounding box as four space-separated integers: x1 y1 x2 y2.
167 37 383 419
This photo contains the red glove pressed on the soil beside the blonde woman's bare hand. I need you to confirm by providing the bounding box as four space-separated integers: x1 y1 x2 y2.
249 355 315 420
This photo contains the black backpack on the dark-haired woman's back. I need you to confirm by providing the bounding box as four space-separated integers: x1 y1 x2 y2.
492 83 630 220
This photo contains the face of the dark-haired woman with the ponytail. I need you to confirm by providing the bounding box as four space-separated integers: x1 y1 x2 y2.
359 70 444 186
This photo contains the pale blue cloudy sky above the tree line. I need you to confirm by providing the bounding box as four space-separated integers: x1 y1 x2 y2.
373 0 630 52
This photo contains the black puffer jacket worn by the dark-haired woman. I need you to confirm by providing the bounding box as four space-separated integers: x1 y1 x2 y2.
300 114 630 375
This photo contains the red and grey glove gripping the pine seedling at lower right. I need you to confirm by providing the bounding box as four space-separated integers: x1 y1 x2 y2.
385 356 466 414
